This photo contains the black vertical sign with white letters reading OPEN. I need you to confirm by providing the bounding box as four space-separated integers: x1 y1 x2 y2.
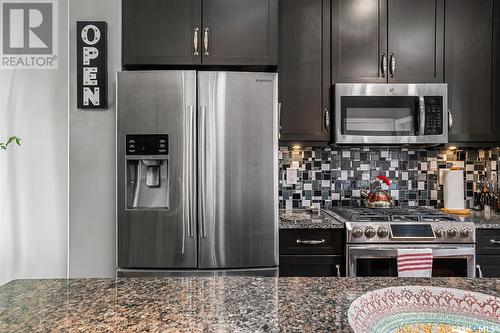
76 21 108 109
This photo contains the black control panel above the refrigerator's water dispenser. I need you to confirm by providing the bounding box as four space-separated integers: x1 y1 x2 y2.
126 134 168 155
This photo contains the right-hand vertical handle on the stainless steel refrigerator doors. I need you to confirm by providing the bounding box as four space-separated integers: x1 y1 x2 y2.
198 106 207 238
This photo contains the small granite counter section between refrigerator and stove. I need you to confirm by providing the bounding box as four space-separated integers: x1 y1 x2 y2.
279 209 345 229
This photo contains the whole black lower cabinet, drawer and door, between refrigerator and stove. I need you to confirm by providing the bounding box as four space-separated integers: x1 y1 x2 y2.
279 229 346 277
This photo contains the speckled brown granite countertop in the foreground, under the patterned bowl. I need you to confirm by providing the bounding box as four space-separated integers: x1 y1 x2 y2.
0 277 500 332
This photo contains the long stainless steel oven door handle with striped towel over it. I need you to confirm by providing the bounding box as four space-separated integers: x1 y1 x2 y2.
349 247 476 258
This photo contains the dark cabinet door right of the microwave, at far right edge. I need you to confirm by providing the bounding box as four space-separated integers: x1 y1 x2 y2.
445 0 499 142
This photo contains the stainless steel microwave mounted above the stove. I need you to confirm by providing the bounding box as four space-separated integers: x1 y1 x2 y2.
335 83 451 144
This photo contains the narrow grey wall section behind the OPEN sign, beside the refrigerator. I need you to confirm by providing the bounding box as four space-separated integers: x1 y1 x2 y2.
69 0 121 277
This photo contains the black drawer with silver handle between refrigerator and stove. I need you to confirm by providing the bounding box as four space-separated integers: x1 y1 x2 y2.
280 229 344 255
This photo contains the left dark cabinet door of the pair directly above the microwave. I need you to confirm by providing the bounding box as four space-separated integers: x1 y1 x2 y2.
332 0 388 83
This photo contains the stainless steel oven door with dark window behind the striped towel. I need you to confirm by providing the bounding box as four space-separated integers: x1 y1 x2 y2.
347 244 476 277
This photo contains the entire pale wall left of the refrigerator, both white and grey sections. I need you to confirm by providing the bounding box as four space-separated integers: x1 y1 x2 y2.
0 0 121 285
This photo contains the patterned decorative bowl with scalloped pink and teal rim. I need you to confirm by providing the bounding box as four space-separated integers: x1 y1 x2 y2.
348 286 500 333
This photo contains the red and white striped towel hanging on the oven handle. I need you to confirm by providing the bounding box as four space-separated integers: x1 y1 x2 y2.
398 249 432 277
